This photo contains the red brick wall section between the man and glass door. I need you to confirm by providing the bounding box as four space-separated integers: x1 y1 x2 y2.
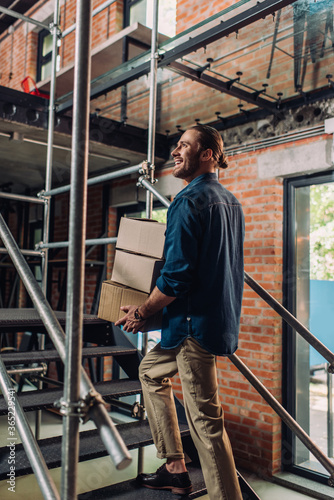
220 152 283 474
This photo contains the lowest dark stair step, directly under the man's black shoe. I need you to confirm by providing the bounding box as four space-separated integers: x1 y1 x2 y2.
78 464 206 500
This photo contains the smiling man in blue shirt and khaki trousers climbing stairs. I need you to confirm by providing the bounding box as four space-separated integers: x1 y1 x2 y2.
116 125 244 500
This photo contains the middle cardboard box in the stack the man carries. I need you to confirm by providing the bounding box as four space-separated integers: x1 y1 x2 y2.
111 250 164 293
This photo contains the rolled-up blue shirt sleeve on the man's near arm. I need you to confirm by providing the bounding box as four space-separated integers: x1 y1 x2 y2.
156 197 201 297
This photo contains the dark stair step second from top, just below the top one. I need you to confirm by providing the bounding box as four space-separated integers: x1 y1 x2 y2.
1 346 137 366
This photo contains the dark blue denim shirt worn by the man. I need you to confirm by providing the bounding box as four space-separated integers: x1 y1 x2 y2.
157 173 244 355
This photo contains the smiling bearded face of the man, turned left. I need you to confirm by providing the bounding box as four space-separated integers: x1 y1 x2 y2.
172 129 201 182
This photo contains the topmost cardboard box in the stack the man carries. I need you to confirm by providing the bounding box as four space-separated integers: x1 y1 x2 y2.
116 217 166 259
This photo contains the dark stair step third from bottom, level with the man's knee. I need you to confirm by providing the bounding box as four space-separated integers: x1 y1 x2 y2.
0 379 141 415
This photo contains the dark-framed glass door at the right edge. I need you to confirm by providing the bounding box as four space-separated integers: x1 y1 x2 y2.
283 172 334 481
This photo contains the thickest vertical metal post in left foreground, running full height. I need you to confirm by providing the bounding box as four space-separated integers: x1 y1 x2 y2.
61 0 92 500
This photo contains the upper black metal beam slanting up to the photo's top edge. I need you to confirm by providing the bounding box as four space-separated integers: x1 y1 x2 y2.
57 0 296 112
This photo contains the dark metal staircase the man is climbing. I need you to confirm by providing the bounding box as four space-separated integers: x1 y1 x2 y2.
0 309 258 500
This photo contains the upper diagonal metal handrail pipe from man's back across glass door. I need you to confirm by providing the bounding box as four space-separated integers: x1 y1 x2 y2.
245 272 334 373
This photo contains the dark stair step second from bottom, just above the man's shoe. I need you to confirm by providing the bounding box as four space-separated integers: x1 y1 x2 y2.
0 420 189 480
